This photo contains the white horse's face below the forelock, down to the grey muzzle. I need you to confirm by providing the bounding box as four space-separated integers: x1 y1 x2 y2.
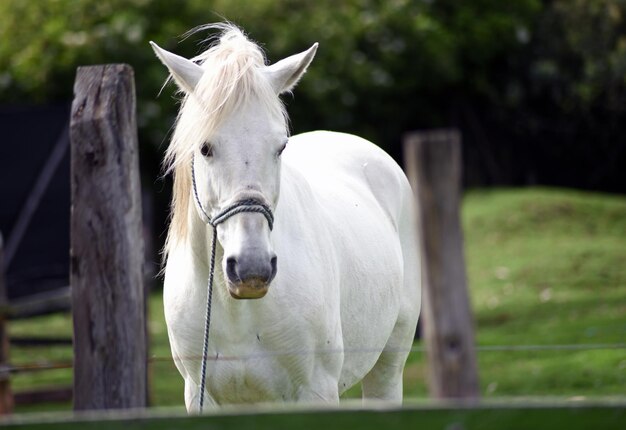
194 101 287 299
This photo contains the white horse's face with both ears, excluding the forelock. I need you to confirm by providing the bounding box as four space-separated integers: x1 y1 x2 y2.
152 37 317 299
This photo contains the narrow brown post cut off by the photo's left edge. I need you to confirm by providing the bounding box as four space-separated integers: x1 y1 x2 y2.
0 232 13 415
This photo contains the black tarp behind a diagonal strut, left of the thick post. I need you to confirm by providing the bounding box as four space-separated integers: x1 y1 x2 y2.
0 104 70 300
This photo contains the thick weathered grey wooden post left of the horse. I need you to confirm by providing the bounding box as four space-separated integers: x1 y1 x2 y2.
70 64 146 410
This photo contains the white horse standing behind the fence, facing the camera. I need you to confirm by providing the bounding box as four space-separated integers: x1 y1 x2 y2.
152 24 420 411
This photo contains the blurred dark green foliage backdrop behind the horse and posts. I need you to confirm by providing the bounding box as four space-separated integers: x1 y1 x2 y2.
0 0 626 197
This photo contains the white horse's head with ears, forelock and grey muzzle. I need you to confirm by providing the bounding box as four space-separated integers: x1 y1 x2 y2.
152 26 317 299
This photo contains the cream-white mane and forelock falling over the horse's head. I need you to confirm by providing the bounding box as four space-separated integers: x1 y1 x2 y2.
164 24 287 254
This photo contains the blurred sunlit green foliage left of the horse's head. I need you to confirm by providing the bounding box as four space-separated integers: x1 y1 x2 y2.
0 0 210 142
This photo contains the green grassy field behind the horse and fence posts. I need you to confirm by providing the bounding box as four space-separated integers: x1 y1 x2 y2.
10 189 626 411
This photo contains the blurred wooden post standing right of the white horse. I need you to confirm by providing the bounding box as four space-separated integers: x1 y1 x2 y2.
404 130 479 398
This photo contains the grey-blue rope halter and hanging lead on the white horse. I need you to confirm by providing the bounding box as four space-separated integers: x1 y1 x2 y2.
191 158 274 412
